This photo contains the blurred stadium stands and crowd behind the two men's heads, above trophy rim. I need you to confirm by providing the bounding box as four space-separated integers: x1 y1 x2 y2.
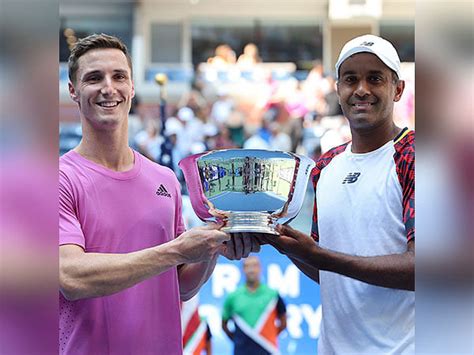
59 0 415 163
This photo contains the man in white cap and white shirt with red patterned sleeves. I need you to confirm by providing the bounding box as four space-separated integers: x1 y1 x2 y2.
261 35 415 354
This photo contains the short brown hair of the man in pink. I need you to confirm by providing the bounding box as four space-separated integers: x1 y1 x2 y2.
68 33 132 83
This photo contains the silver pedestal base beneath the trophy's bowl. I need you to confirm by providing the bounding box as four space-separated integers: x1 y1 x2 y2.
221 212 278 235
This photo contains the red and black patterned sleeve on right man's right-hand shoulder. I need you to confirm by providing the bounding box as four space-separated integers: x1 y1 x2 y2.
396 136 415 241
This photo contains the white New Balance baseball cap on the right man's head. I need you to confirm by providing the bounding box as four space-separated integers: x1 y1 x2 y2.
336 35 401 79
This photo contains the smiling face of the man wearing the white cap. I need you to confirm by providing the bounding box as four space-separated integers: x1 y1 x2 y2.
337 53 405 134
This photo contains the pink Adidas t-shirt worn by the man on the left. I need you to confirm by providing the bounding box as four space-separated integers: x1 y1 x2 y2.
59 151 184 355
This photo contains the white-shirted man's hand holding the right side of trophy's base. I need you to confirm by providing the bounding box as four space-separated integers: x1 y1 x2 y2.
258 224 318 259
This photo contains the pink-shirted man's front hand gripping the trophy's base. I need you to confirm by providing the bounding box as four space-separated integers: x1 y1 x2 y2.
173 223 231 263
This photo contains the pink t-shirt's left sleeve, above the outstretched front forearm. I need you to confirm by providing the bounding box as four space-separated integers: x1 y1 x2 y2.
59 171 85 249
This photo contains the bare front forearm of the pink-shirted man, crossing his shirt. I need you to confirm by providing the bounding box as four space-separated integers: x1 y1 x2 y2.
59 242 183 300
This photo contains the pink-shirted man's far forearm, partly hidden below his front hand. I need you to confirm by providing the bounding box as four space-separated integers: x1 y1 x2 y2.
178 256 217 301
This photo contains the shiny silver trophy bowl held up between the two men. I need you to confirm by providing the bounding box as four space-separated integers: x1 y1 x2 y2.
179 149 315 234
